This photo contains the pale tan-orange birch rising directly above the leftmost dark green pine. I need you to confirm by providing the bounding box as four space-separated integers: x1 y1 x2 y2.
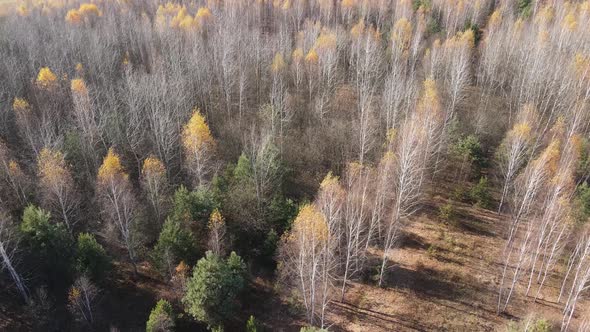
37 148 79 232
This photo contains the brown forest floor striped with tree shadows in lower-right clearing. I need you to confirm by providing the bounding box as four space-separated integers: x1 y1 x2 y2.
249 178 590 331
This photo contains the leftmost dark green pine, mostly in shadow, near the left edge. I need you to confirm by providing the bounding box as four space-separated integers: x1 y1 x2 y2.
20 205 73 288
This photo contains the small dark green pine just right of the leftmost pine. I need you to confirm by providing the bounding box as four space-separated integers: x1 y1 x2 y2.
76 233 111 282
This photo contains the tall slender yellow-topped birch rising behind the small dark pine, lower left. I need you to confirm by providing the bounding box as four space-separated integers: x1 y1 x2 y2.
96 148 139 273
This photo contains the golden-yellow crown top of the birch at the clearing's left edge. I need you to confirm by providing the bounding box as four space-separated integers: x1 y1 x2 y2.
293 204 328 243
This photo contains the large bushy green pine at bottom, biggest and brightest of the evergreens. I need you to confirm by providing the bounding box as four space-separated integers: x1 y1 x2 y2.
182 251 246 328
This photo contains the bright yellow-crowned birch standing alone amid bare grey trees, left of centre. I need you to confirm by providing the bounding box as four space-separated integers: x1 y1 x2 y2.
182 109 215 187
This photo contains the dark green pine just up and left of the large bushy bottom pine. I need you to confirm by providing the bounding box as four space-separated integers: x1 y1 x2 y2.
151 218 198 275
